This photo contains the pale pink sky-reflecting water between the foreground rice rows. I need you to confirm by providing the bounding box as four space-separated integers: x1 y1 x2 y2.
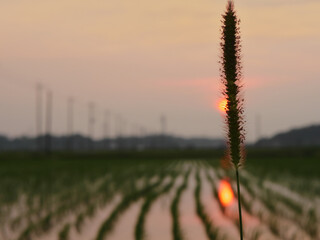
11 163 304 240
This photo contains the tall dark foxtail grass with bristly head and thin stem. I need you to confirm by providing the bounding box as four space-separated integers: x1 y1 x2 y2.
220 0 244 240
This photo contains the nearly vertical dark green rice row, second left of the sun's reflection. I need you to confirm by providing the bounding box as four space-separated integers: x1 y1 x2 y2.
171 170 191 240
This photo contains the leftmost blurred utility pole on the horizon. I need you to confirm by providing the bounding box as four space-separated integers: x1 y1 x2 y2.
36 83 43 151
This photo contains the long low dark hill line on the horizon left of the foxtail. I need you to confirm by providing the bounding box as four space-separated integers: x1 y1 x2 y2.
0 135 225 151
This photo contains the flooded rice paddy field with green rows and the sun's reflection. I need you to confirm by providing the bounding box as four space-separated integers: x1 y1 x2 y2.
0 151 320 240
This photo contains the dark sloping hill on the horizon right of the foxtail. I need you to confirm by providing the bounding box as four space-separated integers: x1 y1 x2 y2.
255 125 320 147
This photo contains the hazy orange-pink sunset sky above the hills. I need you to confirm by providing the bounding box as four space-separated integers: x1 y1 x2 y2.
0 0 320 141
